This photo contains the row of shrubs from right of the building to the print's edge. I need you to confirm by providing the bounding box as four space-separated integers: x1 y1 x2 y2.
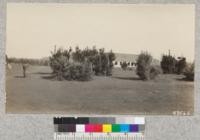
136 52 194 81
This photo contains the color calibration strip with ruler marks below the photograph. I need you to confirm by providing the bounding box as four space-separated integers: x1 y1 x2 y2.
54 117 145 140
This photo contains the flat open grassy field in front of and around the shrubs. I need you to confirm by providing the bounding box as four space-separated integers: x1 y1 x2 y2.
6 64 194 115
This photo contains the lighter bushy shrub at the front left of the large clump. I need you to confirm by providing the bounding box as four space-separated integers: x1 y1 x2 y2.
50 46 92 81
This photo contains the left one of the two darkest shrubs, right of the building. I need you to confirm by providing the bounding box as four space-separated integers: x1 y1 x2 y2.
161 54 177 74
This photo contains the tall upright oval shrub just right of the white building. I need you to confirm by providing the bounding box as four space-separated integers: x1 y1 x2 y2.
136 52 152 80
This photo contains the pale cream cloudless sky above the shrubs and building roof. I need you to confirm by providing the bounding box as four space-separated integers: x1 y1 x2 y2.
6 3 195 61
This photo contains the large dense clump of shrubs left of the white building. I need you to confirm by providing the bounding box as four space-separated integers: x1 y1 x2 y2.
50 47 115 80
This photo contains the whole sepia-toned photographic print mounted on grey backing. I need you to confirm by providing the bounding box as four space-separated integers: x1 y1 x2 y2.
5 3 195 116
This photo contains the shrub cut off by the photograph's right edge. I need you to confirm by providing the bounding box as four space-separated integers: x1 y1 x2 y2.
183 63 194 81
